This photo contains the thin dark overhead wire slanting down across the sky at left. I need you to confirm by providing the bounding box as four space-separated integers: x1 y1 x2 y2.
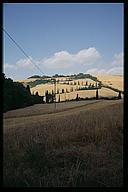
3 28 44 74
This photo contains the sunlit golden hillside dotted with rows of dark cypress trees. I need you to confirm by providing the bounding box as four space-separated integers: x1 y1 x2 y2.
20 73 124 101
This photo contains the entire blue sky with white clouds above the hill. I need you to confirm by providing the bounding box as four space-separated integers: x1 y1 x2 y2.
3 3 124 80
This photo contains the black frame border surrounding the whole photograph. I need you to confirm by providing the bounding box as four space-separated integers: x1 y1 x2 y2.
0 0 128 191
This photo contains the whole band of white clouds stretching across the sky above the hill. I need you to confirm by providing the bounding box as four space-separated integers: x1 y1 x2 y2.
3 47 124 79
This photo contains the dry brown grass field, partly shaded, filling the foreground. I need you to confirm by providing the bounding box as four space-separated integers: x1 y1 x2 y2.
3 100 123 187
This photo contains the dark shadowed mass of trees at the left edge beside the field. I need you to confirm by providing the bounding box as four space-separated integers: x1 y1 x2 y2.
2 74 43 112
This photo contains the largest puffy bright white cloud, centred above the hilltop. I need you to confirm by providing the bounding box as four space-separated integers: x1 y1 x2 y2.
42 47 101 69
